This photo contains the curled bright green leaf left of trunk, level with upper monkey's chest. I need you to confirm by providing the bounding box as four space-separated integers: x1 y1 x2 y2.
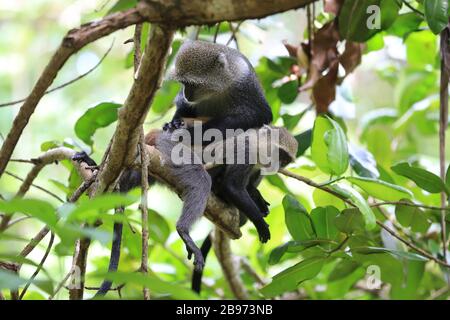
75 102 122 146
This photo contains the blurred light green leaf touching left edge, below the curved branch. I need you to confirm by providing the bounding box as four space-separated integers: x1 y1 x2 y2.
0 198 58 228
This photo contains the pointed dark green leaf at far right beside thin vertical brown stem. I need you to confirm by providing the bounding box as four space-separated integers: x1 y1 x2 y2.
391 162 446 193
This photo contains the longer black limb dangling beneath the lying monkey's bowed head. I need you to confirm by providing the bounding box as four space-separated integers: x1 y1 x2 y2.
222 165 270 243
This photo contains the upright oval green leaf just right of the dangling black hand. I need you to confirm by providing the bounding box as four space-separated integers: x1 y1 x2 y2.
283 194 316 241
